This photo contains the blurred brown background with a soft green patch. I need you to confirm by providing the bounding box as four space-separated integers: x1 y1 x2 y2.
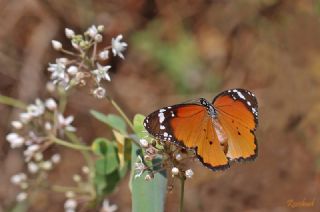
0 0 320 212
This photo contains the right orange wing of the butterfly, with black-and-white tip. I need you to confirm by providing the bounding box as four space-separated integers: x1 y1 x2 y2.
213 89 258 161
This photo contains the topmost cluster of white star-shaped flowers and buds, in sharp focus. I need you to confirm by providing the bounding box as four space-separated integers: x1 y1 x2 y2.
48 25 127 99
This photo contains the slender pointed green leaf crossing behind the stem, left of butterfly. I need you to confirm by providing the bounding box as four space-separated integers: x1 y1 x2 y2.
90 110 127 134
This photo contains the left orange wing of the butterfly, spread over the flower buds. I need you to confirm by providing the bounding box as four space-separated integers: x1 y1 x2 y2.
144 103 229 170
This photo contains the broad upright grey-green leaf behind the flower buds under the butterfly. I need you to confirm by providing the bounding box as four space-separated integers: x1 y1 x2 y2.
130 115 167 212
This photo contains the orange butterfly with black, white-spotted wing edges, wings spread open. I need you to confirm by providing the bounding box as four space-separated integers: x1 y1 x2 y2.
143 89 258 170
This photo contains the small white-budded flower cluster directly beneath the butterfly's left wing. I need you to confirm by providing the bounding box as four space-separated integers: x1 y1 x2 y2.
135 137 195 184
